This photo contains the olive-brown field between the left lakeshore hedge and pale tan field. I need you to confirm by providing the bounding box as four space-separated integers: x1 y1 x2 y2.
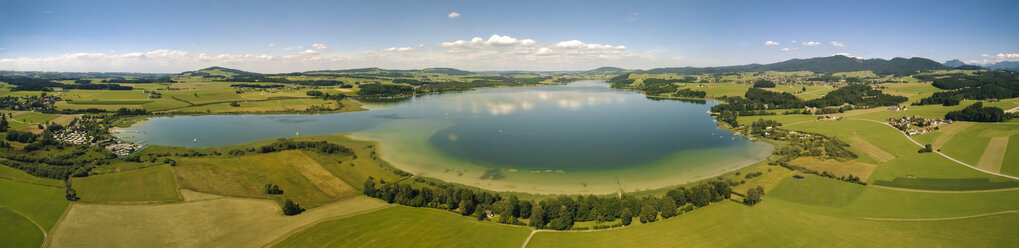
173 150 360 208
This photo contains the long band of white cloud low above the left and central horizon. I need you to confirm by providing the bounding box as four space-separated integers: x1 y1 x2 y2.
0 35 684 72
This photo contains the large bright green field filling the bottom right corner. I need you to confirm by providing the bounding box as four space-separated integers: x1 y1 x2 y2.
528 177 1019 247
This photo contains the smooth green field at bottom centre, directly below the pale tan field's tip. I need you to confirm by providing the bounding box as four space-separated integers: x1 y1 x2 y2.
275 206 531 247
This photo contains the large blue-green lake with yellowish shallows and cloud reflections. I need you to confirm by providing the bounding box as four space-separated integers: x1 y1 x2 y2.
117 81 771 194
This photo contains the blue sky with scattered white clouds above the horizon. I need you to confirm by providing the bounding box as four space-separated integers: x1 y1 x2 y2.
0 0 1019 72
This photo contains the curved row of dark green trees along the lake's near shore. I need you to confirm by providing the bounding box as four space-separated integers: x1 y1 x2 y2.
363 178 739 230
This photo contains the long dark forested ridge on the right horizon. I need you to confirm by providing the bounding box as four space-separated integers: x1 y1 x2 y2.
585 55 949 76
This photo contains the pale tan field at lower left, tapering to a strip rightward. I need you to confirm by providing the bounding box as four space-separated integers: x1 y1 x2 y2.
50 196 389 247
